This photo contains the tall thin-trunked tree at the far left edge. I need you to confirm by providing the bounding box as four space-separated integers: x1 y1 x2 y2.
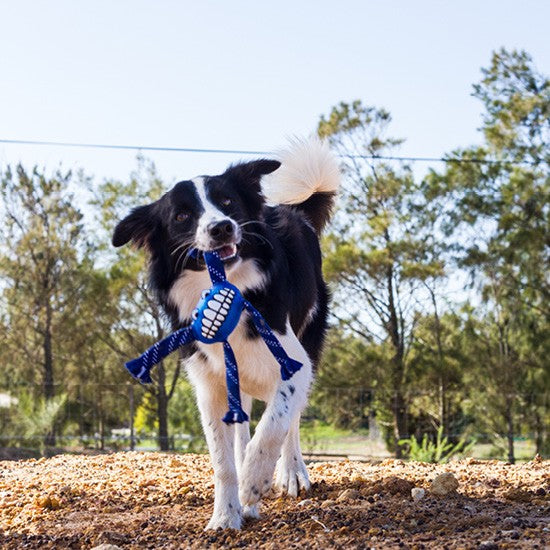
0 165 89 445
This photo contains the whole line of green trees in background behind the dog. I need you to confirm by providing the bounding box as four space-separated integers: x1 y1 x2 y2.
0 50 550 461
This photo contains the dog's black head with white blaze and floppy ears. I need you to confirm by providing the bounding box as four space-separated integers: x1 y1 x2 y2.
113 159 280 269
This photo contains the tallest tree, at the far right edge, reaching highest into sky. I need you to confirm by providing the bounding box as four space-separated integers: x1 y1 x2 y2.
423 49 550 462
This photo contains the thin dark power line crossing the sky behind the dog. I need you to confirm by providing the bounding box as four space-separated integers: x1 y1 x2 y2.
0 139 537 165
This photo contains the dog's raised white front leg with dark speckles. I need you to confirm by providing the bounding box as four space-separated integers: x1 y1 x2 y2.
239 325 311 505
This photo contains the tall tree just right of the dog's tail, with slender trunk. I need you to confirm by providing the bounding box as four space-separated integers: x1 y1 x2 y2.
318 101 443 456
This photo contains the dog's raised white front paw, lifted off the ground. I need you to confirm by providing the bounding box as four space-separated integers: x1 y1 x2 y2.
239 443 277 506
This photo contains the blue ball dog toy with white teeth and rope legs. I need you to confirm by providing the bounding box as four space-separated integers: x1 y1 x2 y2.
126 252 302 424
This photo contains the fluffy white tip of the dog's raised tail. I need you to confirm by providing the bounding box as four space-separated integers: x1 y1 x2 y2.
262 138 340 204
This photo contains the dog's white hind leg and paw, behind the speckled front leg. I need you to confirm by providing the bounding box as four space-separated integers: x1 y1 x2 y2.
275 415 311 497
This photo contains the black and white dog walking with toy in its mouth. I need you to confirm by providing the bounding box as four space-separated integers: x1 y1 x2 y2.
113 140 340 529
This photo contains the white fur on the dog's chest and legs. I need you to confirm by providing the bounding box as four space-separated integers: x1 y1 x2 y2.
170 260 312 529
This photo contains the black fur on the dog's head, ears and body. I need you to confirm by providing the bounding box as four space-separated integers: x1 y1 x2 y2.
113 160 334 365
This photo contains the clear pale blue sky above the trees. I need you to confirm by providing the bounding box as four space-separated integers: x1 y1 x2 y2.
0 0 550 187
